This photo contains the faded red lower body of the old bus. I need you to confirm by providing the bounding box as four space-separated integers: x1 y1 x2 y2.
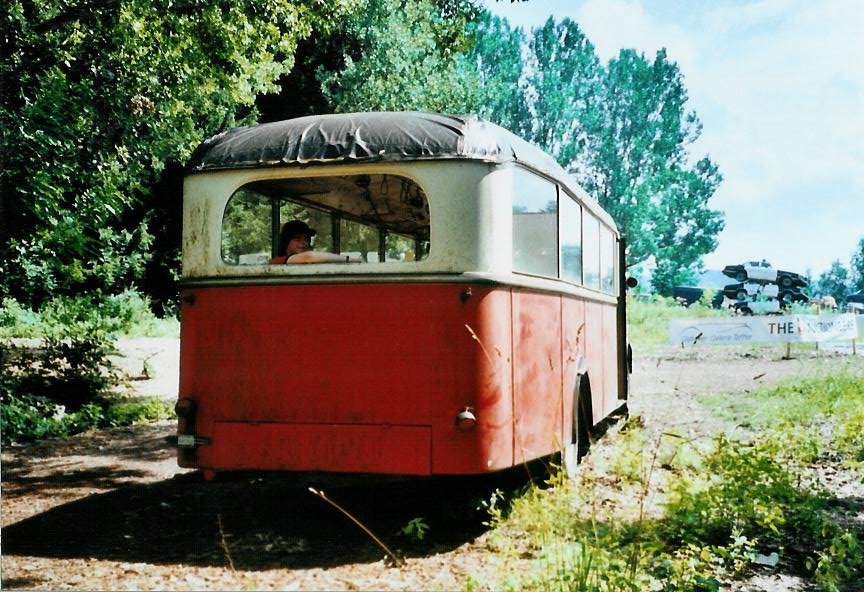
178 284 617 475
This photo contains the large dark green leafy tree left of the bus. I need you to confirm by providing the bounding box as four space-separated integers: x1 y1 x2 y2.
0 0 350 305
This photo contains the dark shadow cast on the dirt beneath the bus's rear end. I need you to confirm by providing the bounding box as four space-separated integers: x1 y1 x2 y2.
3 473 520 572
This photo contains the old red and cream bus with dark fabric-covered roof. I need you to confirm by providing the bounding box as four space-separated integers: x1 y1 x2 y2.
177 113 628 478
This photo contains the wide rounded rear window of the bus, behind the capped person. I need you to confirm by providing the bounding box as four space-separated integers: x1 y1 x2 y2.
221 174 431 265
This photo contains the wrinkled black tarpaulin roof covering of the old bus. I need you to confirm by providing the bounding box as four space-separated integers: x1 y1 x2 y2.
187 112 567 178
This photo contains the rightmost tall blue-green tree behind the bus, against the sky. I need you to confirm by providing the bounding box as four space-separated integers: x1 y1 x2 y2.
583 50 724 293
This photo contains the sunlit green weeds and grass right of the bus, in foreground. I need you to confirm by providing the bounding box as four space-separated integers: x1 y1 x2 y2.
482 364 864 592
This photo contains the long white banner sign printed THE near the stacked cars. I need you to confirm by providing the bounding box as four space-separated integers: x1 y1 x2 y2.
669 314 858 345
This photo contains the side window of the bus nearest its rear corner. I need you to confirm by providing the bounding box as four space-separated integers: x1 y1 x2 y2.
513 169 558 278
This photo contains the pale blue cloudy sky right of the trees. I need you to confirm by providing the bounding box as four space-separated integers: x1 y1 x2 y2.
484 0 864 277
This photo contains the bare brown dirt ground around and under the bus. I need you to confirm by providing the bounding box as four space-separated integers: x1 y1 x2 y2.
0 340 864 592
